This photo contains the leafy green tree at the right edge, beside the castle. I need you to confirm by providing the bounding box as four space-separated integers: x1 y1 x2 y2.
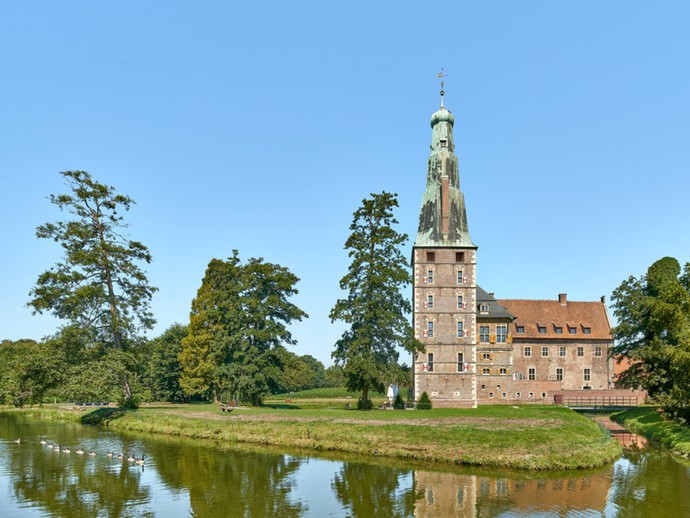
612 257 690 421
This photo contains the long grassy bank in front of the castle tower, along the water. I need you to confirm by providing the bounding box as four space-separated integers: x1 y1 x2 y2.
5 405 620 470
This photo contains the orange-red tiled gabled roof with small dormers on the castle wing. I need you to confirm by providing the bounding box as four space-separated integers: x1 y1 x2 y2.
498 294 612 340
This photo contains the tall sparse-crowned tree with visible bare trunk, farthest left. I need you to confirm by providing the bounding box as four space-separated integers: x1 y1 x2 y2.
28 171 156 403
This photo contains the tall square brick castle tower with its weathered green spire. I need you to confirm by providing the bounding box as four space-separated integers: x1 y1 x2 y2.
412 90 477 407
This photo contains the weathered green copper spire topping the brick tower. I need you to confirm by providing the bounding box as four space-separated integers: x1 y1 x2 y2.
415 99 476 248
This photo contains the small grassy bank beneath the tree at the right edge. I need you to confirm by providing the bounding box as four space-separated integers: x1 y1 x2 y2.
611 406 690 458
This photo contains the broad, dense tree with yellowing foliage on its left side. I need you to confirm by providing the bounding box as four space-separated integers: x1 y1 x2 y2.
179 250 307 404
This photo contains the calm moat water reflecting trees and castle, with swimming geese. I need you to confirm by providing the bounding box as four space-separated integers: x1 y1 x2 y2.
0 415 690 518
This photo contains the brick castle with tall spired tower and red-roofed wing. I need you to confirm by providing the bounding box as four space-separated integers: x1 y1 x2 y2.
412 94 614 408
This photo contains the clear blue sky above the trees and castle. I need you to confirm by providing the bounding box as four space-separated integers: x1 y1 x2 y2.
0 0 690 365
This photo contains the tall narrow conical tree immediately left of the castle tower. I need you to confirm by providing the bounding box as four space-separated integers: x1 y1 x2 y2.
330 191 422 408
